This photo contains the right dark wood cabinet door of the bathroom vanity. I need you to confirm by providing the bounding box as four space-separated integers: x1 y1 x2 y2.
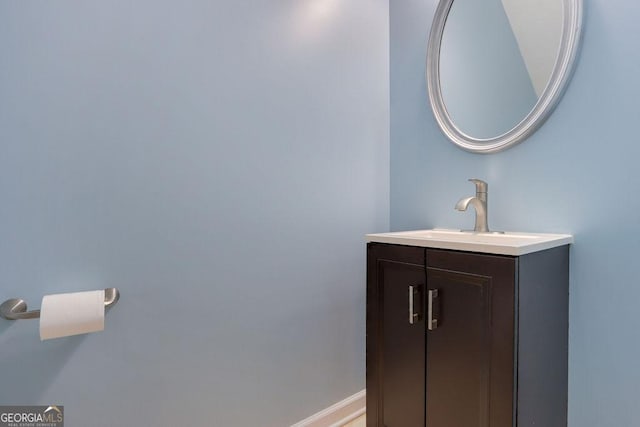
426 249 516 427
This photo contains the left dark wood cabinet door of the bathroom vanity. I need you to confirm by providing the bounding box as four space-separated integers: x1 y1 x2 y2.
367 244 426 427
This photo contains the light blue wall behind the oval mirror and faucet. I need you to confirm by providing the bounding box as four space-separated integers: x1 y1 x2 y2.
390 0 640 427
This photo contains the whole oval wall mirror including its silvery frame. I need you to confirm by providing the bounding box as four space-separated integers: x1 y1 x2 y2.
427 0 582 153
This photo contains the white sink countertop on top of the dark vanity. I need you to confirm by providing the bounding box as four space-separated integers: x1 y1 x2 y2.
367 229 573 256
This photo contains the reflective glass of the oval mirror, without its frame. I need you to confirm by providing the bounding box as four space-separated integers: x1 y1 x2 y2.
439 0 564 139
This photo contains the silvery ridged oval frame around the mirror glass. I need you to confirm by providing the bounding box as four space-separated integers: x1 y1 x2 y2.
427 0 582 154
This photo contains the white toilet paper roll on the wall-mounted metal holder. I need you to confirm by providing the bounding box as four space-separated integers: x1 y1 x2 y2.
40 289 104 340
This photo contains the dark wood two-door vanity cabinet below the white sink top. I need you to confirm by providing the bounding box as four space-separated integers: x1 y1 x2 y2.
366 242 569 427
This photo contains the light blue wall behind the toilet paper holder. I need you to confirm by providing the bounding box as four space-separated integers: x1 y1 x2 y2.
0 0 389 427
